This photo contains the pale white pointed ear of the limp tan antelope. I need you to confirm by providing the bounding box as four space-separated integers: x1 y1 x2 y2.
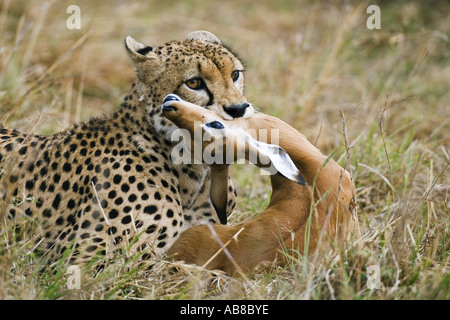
250 138 306 186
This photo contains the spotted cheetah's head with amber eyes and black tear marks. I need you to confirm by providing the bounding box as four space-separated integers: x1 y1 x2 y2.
125 31 254 134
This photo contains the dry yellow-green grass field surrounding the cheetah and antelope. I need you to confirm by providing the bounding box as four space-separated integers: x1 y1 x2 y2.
0 0 450 299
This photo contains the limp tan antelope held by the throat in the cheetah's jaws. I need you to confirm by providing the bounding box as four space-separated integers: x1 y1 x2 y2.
161 94 357 275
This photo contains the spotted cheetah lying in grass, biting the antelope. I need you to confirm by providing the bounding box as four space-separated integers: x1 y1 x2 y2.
0 31 254 263
